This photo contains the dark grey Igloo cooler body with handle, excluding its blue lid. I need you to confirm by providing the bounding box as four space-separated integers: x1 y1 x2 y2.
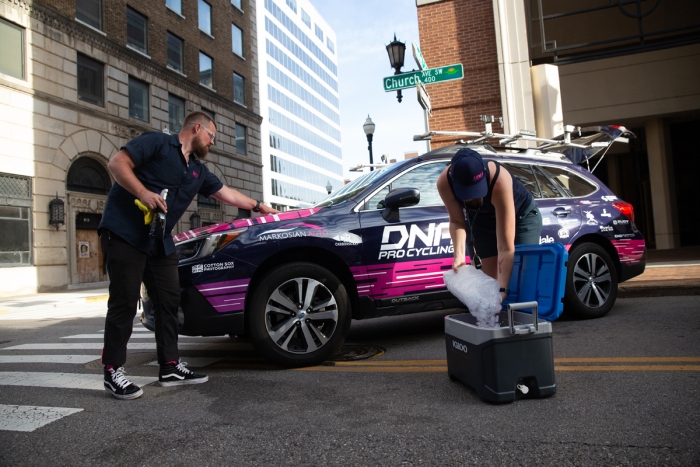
445 302 557 403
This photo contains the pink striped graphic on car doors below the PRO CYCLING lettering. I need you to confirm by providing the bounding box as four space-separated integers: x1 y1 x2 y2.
350 257 454 299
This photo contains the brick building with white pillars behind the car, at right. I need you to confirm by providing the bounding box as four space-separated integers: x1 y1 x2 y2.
416 0 700 249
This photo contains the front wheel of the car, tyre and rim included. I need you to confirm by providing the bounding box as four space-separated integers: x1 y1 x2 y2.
248 263 350 367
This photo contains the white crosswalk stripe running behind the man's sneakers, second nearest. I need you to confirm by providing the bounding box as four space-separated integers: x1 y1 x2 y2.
0 371 158 391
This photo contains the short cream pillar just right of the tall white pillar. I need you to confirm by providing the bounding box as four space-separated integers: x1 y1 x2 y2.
530 65 564 138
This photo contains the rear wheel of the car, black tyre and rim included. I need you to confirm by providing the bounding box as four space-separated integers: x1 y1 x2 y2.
564 243 617 319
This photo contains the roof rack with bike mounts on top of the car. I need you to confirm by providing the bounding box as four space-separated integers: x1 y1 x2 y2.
413 115 636 172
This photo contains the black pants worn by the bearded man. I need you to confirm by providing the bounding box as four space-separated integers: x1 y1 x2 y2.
100 230 180 367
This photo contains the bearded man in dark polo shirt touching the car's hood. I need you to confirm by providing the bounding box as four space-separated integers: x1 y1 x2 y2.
99 112 277 399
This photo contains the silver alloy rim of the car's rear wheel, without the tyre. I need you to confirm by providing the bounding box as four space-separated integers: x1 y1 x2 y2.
572 253 612 308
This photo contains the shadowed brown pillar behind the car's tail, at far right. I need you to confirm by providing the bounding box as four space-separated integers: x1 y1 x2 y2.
645 118 681 250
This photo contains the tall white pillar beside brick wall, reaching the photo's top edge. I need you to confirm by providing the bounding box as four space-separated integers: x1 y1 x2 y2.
493 0 535 141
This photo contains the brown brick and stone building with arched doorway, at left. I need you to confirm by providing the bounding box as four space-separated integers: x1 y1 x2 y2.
0 0 263 296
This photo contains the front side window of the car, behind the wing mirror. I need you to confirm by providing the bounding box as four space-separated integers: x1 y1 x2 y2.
367 161 449 209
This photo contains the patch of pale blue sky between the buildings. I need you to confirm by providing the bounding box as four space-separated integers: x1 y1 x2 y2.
311 0 426 183
